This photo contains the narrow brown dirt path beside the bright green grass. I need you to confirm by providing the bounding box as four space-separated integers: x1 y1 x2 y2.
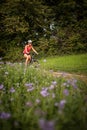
51 72 87 84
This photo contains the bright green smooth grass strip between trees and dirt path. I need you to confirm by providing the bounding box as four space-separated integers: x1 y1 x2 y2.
41 54 87 75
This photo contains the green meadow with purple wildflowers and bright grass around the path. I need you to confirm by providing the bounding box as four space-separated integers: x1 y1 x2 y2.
0 54 87 130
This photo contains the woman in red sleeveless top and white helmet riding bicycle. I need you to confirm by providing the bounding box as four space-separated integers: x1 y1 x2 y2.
23 40 38 66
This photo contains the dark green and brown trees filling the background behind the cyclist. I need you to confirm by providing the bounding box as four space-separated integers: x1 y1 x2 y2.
0 0 87 61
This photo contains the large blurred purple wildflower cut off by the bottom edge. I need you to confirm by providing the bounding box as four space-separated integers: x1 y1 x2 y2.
39 119 54 130
